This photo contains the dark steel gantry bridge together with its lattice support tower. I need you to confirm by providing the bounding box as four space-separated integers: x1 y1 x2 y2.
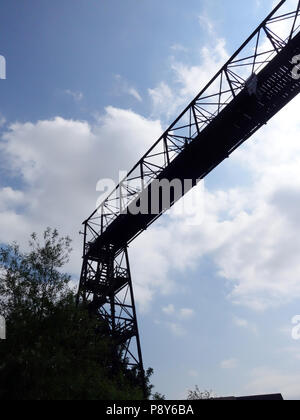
78 0 300 394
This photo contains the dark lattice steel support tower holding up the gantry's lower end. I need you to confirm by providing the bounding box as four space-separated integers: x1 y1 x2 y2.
78 225 146 393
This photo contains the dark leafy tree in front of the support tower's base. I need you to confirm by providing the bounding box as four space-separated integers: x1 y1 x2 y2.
0 228 146 400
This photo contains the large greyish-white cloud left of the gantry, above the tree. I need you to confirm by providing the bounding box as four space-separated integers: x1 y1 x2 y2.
0 107 163 306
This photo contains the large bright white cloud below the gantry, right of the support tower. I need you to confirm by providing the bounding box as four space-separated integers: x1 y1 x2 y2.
132 92 300 312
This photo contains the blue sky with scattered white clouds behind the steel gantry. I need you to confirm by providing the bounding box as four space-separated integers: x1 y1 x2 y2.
0 0 300 399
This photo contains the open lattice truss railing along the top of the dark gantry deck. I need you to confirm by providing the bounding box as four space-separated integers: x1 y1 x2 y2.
87 2 300 240
